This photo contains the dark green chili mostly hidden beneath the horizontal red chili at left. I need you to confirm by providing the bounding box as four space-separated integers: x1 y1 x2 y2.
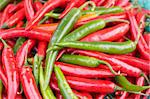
13 37 26 54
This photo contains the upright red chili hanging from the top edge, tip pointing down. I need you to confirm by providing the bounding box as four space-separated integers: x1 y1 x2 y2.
24 0 35 21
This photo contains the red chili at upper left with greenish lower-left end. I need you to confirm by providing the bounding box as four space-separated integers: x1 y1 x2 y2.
1 8 25 28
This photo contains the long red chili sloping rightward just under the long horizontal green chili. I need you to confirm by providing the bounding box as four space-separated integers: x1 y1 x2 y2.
75 50 141 77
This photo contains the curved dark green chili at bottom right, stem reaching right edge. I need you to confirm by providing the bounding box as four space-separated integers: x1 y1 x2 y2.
115 75 150 92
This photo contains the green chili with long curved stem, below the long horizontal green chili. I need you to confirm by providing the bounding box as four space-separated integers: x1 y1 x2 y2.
59 54 117 75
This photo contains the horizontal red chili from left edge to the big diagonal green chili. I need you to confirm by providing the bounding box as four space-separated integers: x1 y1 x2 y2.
0 28 52 42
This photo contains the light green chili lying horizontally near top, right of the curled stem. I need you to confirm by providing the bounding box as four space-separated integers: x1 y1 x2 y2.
82 7 124 15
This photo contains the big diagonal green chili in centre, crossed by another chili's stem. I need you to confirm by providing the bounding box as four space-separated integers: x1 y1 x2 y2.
44 8 81 89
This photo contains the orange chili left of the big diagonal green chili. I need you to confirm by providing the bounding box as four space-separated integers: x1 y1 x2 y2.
33 23 58 32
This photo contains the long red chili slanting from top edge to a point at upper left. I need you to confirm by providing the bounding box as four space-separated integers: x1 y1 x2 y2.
26 0 67 30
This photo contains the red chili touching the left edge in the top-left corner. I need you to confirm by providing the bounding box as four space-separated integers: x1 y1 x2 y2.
0 4 14 27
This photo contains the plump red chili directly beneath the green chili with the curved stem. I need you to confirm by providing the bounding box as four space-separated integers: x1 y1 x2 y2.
55 62 115 78
